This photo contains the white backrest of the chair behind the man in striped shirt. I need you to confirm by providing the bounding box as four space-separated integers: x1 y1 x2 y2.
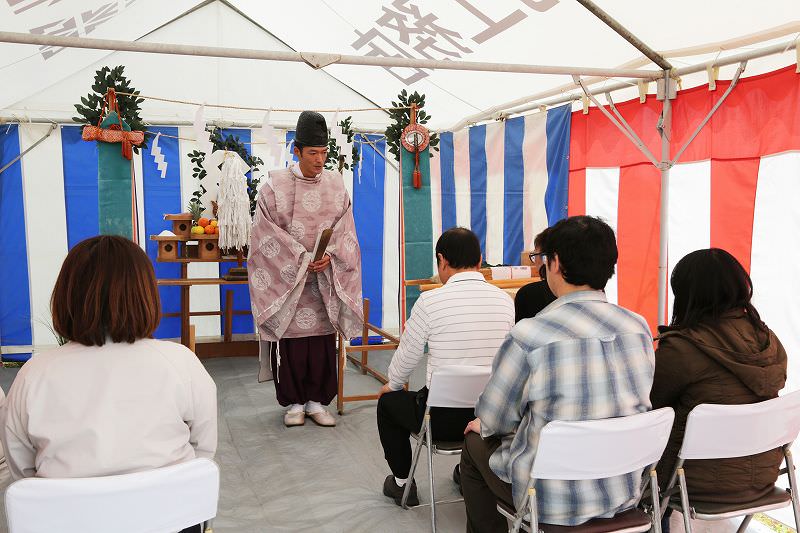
428 365 492 408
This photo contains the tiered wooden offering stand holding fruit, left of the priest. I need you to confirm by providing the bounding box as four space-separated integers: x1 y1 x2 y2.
150 213 253 358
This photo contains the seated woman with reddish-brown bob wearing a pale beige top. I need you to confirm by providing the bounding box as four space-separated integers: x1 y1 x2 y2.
0 235 217 529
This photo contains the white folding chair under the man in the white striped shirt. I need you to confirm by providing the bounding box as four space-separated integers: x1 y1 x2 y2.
400 365 491 533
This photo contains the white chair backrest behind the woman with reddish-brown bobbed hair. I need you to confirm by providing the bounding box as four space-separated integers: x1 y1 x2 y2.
6 459 219 533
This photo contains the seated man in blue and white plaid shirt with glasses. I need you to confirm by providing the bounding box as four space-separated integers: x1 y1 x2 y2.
460 216 655 533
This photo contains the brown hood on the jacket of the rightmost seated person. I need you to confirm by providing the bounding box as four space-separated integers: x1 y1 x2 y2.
659 313 786 397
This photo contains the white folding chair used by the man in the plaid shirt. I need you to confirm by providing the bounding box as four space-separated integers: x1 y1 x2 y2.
497 407 675 533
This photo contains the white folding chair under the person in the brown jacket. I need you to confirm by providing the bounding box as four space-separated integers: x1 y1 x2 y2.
662 391 800 533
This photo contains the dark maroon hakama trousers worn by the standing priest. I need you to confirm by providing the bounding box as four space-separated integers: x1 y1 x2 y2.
269 333 338 407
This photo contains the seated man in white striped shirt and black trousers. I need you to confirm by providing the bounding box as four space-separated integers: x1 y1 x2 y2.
378 228 514 505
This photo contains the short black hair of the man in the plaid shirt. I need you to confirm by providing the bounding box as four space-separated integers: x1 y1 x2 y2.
542 216 617 290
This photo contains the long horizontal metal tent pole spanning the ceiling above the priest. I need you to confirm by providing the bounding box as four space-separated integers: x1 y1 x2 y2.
0 31 657 79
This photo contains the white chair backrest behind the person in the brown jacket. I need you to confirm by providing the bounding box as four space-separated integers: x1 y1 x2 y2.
678 391 800 459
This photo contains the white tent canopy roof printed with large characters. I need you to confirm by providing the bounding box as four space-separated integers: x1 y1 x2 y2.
0 0 800 130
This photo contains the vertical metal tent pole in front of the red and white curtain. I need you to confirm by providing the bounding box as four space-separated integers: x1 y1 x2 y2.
657 70 674 326
